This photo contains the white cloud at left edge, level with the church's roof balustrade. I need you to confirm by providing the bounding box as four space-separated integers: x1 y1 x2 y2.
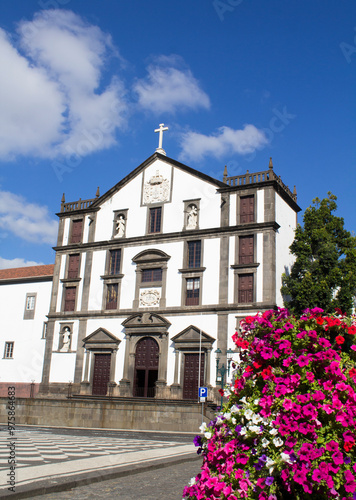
0 191 58 245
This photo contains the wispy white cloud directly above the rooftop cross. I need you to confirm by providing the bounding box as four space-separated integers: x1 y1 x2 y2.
134 55 210 113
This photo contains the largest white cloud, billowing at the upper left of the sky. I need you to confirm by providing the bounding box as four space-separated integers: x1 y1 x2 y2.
0 10 127 159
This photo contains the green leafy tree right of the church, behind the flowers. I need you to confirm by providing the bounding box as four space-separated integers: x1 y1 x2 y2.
281 192 356 315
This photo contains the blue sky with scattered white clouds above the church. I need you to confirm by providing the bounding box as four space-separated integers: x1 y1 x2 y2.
0 0 356 268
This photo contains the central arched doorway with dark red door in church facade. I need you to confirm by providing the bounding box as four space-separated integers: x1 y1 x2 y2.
134 337 159 398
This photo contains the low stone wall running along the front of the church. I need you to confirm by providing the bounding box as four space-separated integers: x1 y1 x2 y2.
0 398 214 432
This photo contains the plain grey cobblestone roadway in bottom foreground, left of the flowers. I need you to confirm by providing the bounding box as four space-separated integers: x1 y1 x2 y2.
31 459 202 500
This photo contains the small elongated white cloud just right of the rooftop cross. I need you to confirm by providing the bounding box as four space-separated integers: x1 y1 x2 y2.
180 125 268 161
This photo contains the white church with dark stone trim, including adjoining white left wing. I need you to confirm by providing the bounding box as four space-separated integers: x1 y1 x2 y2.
0 134 300 400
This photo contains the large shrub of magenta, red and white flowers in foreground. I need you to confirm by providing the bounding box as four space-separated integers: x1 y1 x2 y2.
183 308 356 500
